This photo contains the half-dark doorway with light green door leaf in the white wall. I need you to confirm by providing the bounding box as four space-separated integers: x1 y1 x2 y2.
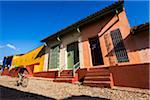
67 42 79 69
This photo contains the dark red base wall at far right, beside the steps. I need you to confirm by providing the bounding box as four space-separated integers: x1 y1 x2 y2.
110 63 150 89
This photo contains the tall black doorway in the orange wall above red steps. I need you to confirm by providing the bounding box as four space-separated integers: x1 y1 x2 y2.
89 36 104 66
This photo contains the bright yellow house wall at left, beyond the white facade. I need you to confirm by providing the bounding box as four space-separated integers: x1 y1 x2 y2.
12 45 44 72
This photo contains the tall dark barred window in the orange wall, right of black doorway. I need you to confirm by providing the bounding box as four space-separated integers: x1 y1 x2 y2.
110 29 129 62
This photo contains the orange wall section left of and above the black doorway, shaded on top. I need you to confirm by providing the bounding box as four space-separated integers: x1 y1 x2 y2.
81 12 112 68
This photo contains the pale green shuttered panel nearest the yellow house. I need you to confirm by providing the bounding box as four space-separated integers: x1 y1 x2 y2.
49 46 60 69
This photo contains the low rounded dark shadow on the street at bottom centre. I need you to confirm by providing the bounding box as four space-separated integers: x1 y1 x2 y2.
62 95 109 100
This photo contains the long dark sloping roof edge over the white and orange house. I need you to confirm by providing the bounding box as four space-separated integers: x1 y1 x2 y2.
41 1 124 42
